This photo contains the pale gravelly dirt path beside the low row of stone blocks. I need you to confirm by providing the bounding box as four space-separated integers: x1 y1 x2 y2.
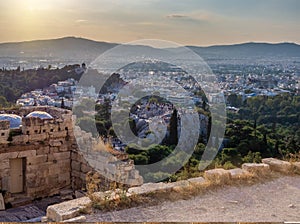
87 176 300 222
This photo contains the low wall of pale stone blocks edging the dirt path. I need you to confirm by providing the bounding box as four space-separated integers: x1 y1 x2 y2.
43 158 300 222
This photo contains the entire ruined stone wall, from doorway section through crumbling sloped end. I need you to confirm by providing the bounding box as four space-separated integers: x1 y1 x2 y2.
0 107 142 206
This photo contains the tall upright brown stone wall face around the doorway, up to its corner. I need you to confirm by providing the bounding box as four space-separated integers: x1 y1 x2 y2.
0 107 72 202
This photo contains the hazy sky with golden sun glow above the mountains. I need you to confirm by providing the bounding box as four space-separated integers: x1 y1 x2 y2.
0 0 300 46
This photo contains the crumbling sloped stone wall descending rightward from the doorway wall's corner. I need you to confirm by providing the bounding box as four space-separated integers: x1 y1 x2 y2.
72 127 143 189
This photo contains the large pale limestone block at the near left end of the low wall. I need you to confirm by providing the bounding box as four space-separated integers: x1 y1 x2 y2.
47 197 92 222
